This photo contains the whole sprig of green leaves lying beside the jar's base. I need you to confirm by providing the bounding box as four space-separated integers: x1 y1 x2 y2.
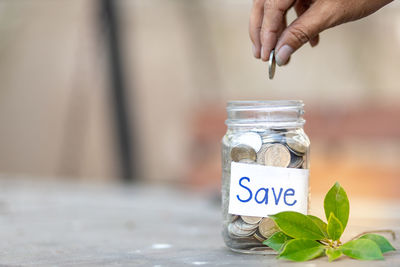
263 183 395 261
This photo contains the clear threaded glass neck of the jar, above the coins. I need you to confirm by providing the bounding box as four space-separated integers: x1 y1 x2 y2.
225 100 305 129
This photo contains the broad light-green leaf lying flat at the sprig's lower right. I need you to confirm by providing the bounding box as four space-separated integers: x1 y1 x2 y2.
340 238 383 260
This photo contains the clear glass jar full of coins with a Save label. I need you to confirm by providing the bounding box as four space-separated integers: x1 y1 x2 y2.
222 101 310 254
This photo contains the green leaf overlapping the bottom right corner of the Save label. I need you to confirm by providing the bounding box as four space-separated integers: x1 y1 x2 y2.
269 211 324 240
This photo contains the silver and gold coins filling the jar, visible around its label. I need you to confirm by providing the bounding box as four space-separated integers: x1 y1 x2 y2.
223 129 309 247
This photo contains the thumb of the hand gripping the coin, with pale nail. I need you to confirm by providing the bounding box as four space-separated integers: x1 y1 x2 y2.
275 5 329 66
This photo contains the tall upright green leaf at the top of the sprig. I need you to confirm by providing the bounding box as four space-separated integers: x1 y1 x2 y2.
324 182 350 230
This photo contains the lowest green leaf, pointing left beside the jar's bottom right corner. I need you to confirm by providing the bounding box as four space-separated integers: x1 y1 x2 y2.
278 239 324 261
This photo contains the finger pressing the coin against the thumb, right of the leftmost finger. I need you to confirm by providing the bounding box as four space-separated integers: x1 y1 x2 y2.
260 0 295 61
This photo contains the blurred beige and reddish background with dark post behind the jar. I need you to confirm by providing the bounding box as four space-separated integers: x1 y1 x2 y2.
0 0 400 199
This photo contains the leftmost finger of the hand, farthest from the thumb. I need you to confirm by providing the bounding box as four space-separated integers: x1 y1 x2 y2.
249 0 265 58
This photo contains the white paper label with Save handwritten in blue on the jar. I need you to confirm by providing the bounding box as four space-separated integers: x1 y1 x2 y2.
229 162 309 217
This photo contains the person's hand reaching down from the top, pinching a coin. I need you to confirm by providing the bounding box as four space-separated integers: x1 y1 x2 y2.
249 0 392 66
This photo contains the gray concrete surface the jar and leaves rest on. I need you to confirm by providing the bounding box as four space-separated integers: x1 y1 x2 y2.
0 177 400 267
